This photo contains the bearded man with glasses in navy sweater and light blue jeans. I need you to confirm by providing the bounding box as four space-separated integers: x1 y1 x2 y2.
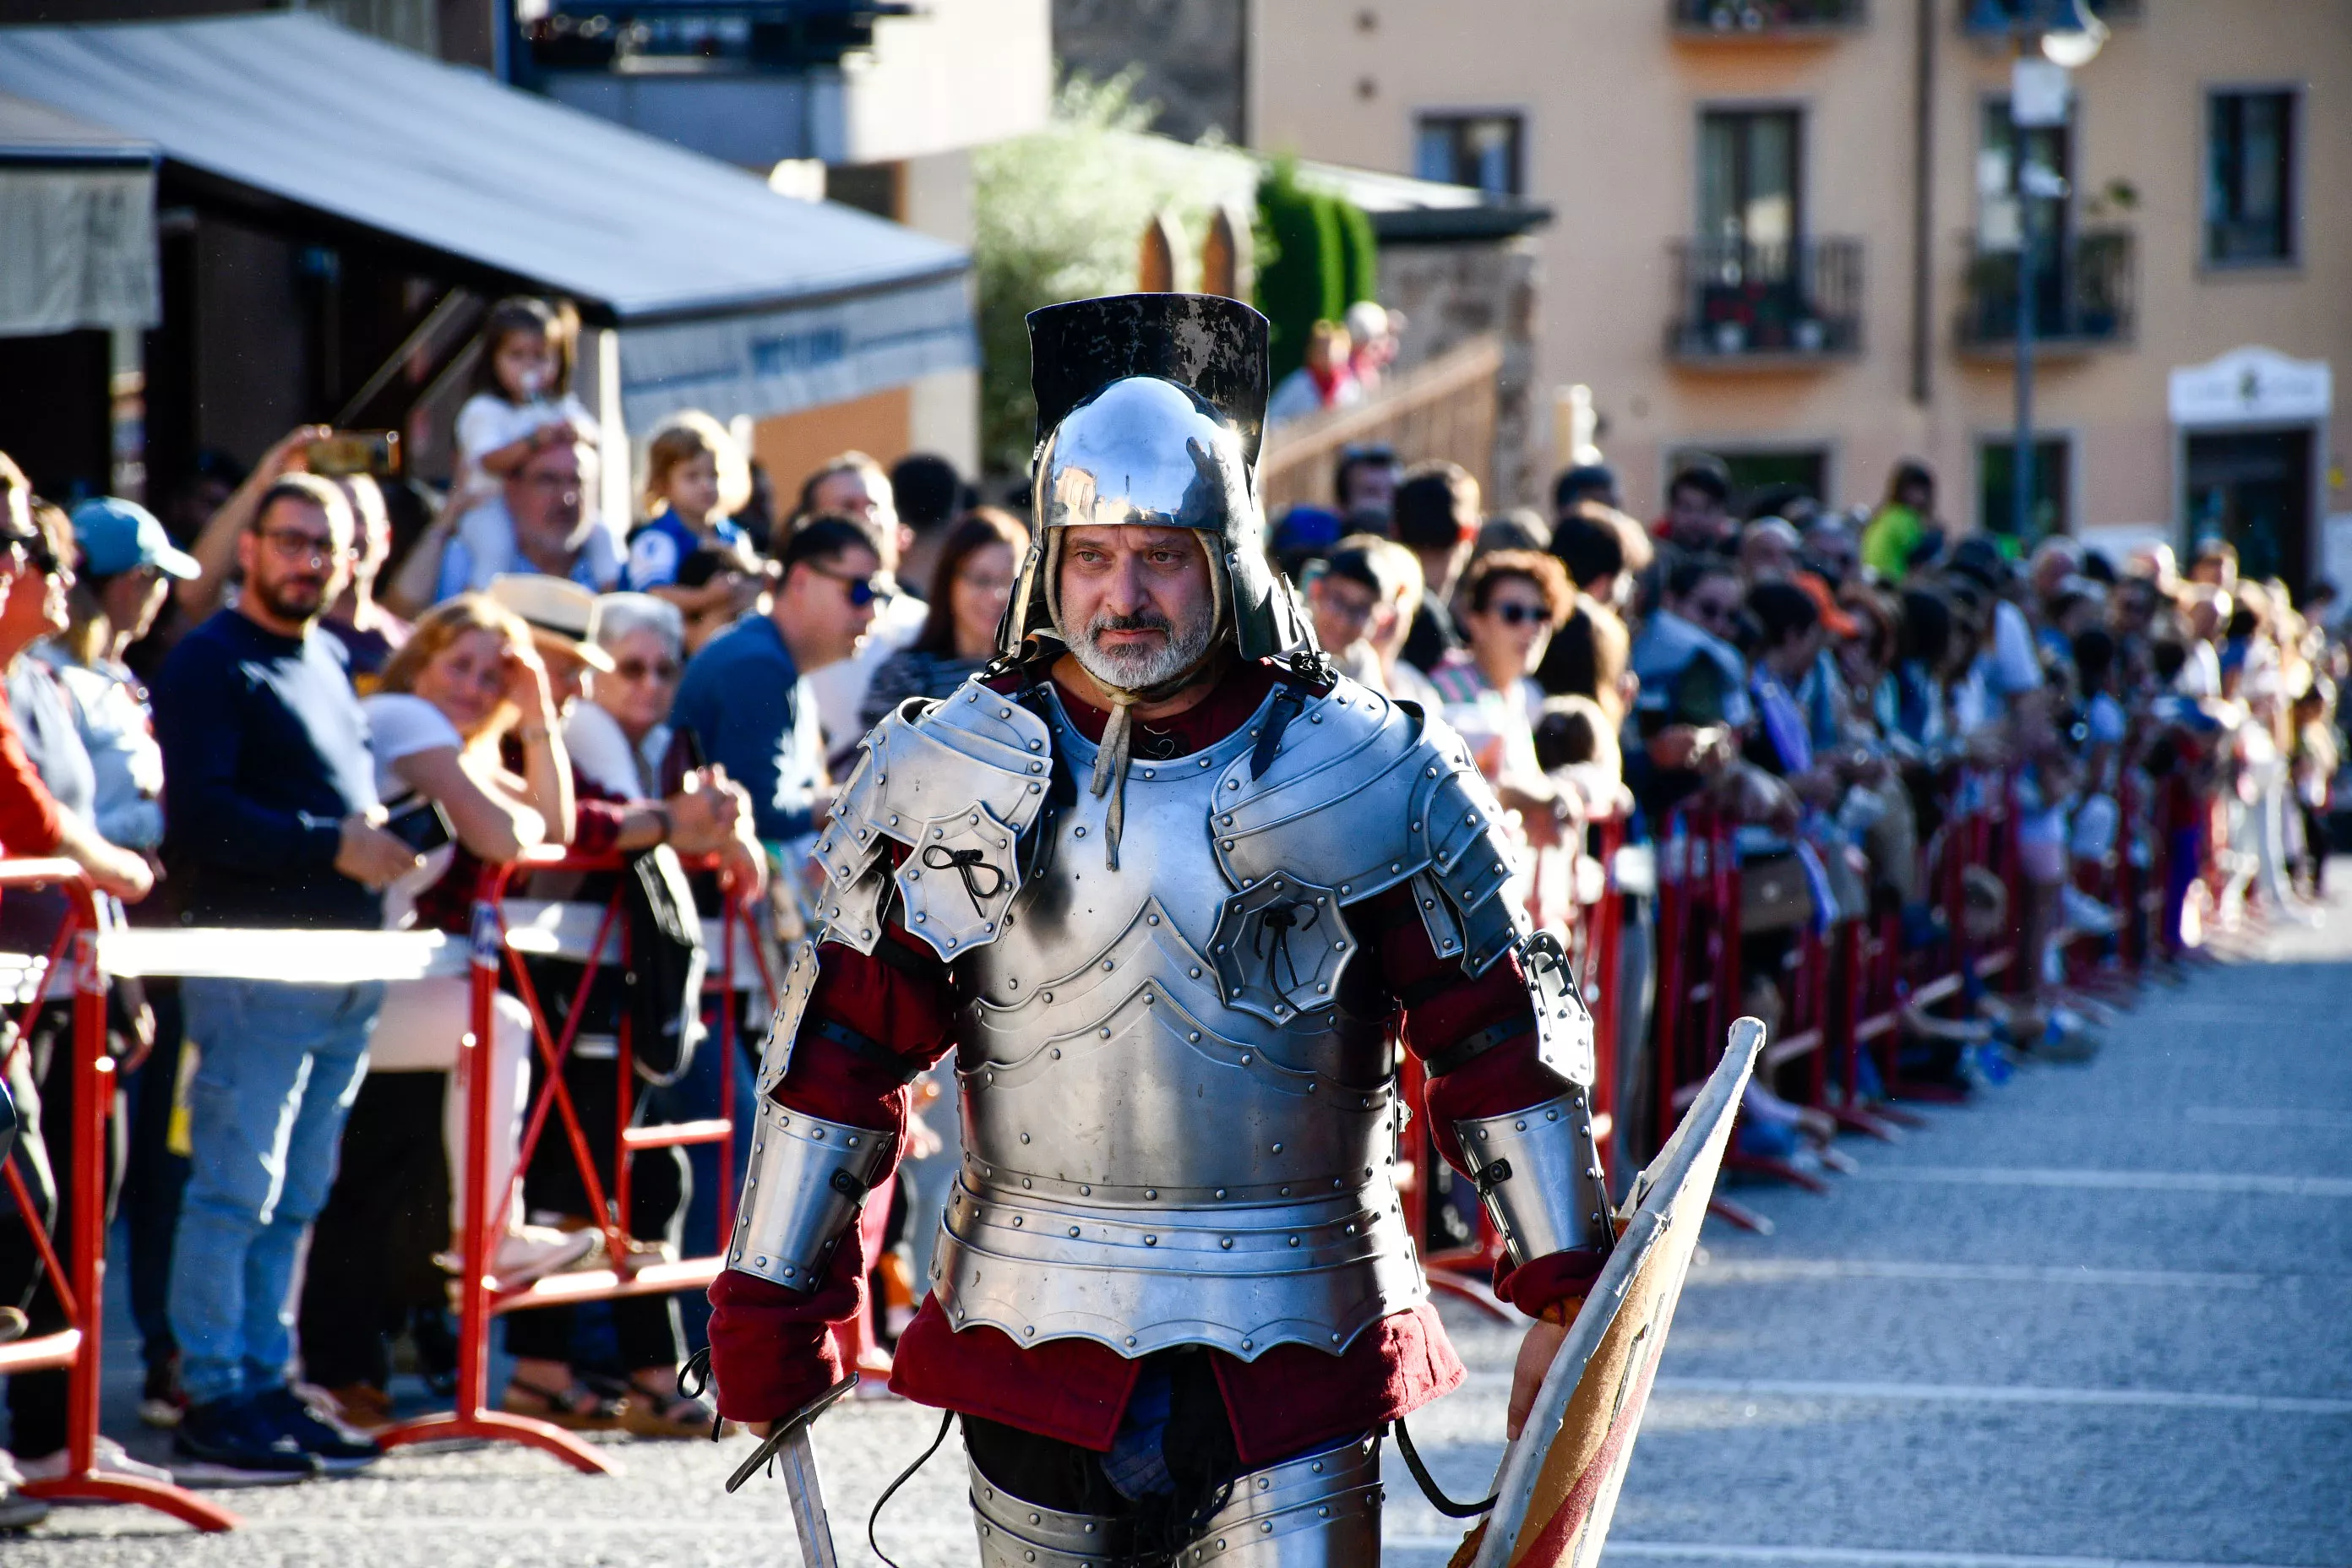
155 475 419 1484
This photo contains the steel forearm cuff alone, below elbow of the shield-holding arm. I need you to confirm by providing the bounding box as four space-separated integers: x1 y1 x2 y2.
1454 1086 1614 1267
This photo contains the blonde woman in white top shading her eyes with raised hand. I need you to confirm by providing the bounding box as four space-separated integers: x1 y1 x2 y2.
301 592 595 1424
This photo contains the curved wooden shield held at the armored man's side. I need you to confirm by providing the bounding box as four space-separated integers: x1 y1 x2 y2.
1451 1018 1764 1568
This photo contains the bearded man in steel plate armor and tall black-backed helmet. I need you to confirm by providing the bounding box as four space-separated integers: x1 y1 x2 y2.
710 294 1611 1568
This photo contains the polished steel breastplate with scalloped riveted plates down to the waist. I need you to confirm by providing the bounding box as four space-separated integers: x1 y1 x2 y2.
934 696 1428 1358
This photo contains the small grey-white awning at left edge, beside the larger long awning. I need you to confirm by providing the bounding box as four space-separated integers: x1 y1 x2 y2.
0 94 158 339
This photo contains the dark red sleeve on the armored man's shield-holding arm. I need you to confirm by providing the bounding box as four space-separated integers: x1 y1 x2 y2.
1364 889 1606 1316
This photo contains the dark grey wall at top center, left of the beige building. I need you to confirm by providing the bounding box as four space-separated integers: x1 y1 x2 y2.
1054 0 1249 141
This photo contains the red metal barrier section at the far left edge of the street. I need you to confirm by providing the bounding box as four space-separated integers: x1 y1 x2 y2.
0 860 237 1530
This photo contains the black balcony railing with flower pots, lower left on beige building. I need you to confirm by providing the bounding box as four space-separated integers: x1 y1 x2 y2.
1665 240 1863 369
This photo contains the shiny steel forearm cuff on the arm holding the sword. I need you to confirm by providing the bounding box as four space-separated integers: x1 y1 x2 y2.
727 1097 898 1291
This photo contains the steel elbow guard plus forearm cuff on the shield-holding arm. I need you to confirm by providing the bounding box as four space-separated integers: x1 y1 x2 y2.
1454 934 1614 1267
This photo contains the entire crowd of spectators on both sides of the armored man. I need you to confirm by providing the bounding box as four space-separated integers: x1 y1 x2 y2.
0 301 2345 1523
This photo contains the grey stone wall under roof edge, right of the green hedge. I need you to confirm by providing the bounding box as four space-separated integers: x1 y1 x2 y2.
1380 237 1550 513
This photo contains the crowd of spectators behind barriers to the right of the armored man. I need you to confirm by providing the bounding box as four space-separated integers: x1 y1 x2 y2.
1275 449 2347 1194
